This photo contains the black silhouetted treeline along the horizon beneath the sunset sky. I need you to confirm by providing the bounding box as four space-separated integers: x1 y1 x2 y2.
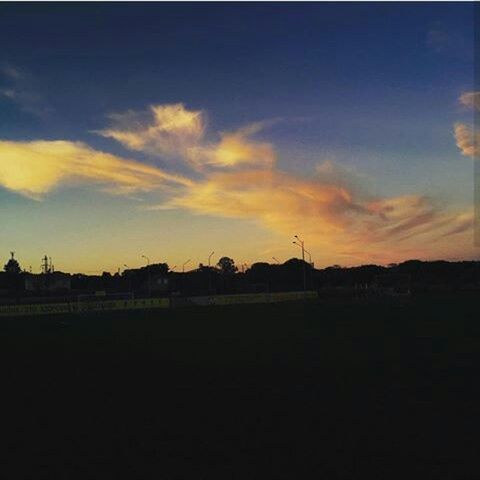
0 257 480 298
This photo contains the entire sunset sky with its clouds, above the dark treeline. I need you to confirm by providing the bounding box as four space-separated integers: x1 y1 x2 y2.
0 3 480 273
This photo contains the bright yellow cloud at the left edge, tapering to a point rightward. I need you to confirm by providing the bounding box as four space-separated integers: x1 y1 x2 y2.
0 140 191 198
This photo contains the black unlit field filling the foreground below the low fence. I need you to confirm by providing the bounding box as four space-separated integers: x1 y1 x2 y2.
0 296 480 480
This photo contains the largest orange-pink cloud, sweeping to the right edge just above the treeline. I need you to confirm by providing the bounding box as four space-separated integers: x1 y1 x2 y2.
164 164 473 262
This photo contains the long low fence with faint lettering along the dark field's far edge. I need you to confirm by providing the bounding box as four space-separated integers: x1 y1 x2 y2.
0 292 317 317
